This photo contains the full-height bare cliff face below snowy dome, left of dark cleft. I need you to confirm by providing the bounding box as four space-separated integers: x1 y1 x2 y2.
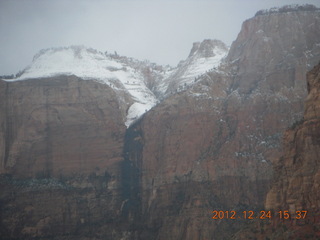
0 76 136 239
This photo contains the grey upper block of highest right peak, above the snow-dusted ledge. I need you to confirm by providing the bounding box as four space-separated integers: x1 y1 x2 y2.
227 6 320 95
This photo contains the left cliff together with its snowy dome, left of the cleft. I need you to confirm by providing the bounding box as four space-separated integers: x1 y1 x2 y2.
0 41 226 239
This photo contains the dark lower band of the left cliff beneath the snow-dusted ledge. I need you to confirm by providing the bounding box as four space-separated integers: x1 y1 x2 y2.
0 174 130 240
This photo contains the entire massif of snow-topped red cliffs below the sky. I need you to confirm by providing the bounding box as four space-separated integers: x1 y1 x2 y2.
0 3 320 240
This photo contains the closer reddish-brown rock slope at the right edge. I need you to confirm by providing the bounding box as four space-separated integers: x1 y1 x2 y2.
232 62 320 240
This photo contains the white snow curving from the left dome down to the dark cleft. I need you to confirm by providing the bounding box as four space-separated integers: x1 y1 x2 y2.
10 46 157 127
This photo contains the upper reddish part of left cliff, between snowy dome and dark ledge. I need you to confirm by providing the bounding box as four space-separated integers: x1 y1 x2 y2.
0 76 125 177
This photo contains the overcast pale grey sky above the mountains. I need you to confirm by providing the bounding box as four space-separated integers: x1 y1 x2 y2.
0 0 320 75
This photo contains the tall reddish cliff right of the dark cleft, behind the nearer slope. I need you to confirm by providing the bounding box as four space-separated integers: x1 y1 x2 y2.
125 5 320 239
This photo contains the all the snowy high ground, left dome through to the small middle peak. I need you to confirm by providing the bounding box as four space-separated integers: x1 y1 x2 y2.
7 40 228 127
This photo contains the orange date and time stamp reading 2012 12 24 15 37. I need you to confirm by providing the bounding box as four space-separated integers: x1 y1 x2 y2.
212 210 308 219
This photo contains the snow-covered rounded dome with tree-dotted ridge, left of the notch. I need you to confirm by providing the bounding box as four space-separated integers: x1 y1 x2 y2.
9 46 166 127
